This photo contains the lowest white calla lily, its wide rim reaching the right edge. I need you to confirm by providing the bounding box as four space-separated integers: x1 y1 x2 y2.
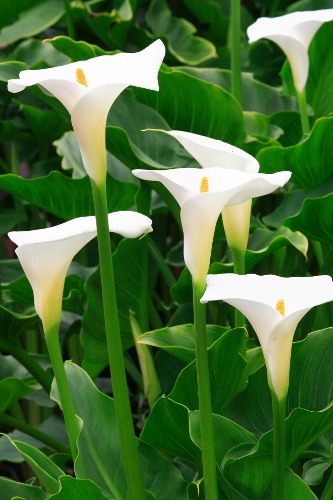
201 274 333 400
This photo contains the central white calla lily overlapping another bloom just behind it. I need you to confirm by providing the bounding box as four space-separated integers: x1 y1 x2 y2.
133 167 291 285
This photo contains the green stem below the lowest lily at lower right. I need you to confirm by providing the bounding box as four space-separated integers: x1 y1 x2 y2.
272 391 286 500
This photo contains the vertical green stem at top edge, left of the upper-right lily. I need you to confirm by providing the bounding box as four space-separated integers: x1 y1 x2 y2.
230 0 243 105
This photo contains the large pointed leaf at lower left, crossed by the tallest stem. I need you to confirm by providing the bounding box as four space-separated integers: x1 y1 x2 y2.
52 362 186 500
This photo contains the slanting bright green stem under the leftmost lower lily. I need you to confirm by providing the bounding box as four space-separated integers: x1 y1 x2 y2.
45 325 80 460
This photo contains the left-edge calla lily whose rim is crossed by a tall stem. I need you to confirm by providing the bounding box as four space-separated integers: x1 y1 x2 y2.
8 211 152 333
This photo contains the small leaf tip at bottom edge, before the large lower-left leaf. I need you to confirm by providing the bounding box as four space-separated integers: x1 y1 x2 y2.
49 476 107 500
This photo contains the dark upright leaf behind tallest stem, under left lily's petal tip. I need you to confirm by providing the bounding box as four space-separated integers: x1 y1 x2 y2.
81 239 148 378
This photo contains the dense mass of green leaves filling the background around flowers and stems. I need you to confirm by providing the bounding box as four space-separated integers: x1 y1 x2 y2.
0 0 333 500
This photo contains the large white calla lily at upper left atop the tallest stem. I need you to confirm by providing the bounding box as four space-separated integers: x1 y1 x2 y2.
8 40 165 185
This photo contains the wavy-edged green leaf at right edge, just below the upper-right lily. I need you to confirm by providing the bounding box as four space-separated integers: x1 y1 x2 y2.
257 118 333 188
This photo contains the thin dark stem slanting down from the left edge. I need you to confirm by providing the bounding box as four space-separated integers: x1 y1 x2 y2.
0 340 52 394
